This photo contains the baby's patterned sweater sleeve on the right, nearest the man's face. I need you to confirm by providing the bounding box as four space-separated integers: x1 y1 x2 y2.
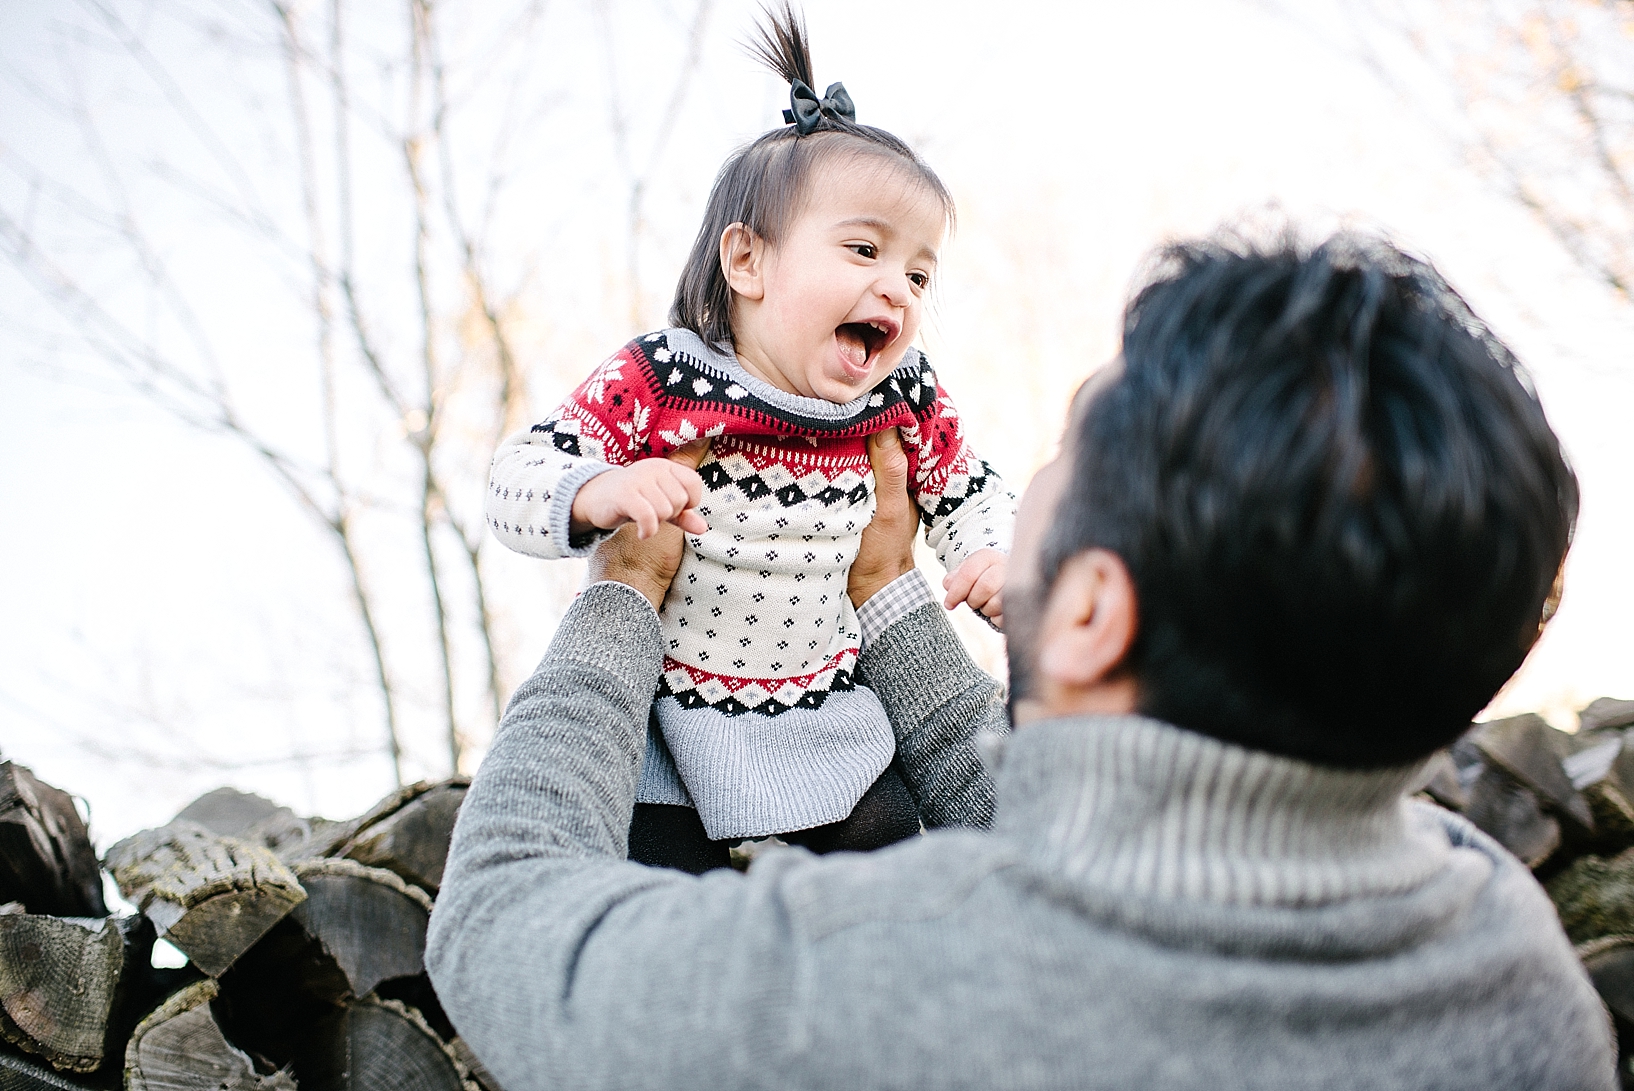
902 384 1016 572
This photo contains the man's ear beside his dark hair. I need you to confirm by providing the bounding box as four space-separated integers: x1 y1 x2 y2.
1038 549 1139 714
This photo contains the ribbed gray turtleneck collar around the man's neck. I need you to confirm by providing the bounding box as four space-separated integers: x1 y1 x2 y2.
995 715 1449 906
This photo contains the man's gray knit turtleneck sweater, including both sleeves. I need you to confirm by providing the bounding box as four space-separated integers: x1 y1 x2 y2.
426 585 1614 1091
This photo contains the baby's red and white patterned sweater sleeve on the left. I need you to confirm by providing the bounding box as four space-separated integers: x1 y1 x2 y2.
487 346 659 559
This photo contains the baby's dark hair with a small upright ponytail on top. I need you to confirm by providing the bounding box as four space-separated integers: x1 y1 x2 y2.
670 0 954 345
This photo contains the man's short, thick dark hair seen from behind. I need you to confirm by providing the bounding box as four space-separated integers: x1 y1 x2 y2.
1041 235 1577 768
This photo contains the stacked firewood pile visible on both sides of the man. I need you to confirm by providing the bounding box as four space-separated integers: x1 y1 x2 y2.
9 699 1634 1091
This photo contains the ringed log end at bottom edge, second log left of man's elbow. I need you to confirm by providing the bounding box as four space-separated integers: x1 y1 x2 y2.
124 980 296 1091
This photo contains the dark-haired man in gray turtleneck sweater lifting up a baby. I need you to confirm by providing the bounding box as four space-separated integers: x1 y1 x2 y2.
426 238 1614 1091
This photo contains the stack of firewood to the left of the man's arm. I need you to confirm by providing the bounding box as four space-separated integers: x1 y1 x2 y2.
0 763 486 1091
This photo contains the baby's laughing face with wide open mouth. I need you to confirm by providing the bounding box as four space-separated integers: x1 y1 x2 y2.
732 158 948 402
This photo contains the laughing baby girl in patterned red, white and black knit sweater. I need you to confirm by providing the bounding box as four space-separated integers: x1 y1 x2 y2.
489 8 1015 871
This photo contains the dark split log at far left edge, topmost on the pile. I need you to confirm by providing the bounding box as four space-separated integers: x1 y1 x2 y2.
0 761 108 916
